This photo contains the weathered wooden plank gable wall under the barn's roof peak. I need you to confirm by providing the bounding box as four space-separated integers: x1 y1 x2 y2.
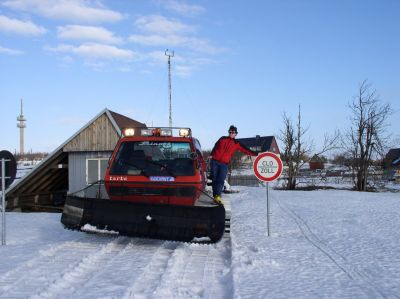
63 113 119 152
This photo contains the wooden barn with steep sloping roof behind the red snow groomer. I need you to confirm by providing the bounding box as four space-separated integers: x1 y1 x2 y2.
6 109 146 210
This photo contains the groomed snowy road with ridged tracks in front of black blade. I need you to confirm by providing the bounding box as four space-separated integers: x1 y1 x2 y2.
0 232 232 298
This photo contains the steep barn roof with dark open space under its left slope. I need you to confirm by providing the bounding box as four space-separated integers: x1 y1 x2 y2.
6 108 146 202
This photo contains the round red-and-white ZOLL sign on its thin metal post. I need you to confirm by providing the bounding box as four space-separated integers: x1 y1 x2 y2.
253 152 283 237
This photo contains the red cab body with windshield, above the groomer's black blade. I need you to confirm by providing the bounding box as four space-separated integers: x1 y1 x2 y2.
104 130 206 206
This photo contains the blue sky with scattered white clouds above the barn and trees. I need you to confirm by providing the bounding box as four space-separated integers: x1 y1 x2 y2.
0 0 400 152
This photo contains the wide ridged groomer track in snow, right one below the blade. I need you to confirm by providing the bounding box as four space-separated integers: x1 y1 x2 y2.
124 239 232 298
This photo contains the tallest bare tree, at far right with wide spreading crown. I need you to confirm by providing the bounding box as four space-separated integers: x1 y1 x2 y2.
343 80 392 191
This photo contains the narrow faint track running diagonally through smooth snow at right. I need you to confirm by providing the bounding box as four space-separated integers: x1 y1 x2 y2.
277 200 400 298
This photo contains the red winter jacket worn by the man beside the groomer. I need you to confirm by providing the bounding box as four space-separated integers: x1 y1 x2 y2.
210 136 257 164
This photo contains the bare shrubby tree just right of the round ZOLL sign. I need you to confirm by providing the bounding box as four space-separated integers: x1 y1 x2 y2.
278 105 340 190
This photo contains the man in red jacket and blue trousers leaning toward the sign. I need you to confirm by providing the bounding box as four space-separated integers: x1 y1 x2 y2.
210 125 257 204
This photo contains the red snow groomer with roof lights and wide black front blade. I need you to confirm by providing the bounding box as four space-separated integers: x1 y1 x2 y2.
61 128 225 242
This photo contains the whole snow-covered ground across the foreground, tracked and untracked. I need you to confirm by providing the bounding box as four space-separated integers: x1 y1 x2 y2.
0 187 400 298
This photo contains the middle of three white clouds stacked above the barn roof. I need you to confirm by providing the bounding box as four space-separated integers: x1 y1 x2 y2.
57 25 122 44
